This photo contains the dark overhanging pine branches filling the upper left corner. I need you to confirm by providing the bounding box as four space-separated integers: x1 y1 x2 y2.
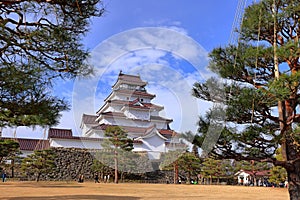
0 0 103 127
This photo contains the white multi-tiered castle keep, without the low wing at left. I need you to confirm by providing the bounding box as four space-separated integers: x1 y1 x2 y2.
81 72 180 159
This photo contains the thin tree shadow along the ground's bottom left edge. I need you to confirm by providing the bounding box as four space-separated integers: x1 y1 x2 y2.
7 195 140 200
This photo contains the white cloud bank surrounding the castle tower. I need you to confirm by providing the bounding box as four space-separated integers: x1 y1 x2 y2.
2 27 218 139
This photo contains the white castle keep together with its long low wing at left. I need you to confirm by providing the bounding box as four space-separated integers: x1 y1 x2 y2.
4 72 185 160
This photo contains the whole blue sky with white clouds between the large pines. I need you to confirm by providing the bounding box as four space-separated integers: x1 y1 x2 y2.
3 0 251 138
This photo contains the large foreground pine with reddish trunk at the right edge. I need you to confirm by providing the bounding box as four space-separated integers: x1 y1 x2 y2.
193 0 300 200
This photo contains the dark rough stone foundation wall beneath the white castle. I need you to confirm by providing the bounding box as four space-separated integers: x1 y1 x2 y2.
34 148 169 183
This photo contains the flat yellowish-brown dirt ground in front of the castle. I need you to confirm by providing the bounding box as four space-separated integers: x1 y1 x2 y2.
0 182 289 200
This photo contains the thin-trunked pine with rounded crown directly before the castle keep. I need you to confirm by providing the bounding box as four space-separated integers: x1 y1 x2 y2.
104 126 133 183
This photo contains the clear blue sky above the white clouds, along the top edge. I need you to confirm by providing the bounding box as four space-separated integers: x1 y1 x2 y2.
84 0 238 51
